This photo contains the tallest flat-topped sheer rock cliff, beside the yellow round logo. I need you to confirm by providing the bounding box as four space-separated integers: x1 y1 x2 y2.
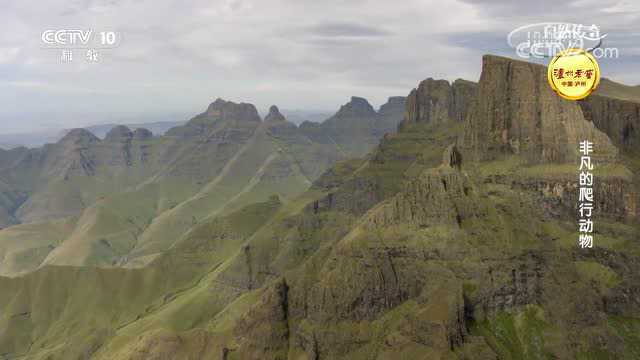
464 55 617 163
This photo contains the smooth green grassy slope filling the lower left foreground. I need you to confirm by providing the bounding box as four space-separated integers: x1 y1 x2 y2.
0 198 281 359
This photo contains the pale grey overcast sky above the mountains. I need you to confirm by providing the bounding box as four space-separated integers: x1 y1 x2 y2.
0 0 640 133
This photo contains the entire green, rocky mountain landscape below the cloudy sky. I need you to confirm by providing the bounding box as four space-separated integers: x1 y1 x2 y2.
0 55 640 360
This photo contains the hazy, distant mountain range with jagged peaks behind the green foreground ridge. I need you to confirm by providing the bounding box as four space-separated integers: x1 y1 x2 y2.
0 98 403 275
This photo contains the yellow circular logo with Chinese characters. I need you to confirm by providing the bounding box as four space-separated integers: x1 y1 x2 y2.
547 49 600 100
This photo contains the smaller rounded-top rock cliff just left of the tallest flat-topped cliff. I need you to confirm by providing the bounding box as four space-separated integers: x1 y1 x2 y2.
404 78 476 123
